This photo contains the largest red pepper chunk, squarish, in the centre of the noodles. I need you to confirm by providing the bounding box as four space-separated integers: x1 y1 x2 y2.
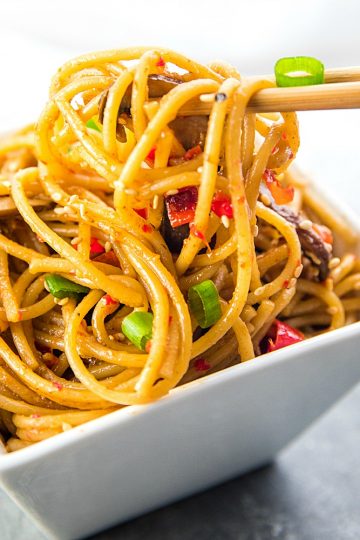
165 186 198 228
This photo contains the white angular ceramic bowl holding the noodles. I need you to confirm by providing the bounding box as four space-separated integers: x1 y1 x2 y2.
0 179 360 539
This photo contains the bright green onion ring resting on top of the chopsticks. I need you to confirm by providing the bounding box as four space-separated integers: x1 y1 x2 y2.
275 56 324 86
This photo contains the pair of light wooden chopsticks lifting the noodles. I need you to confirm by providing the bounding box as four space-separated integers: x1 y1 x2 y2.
179 67 360 116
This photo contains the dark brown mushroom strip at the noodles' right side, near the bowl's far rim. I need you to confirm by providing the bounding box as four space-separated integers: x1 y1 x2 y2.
270 199 332 281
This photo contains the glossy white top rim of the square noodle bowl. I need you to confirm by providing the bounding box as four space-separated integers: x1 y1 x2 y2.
0 154 360 466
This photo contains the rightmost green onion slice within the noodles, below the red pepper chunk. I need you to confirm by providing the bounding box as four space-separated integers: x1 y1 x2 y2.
188 279 221 328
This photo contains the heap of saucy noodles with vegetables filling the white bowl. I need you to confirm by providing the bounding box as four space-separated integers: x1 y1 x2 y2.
0 47 360 452
